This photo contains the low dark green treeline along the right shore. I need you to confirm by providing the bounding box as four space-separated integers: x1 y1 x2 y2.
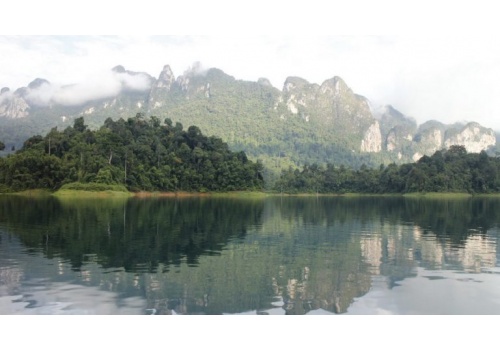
274 146 500 194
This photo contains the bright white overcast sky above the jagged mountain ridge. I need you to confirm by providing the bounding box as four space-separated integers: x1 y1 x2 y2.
0 0 500 130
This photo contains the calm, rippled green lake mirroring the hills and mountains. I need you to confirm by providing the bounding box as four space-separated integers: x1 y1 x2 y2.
0 196 500 315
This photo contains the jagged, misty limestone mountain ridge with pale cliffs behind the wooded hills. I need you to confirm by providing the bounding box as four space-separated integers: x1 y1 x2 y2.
0 65 496 173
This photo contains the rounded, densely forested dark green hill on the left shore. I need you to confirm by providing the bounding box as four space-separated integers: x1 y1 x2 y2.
0 114 263 192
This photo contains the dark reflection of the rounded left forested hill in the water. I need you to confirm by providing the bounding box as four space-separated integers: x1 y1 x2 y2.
0 197 263 272
